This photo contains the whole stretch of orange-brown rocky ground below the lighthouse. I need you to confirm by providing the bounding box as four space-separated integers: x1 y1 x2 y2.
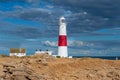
0 54 120 80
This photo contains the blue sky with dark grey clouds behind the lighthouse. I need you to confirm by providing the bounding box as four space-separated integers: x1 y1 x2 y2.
0 0 120 56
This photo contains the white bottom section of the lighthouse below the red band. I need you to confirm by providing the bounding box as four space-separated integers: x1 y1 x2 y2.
58 46 68 57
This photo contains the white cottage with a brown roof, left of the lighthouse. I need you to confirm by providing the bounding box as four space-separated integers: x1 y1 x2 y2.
10 48 26 57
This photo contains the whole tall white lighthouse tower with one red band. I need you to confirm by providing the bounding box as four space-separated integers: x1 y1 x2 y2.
58 17 68 57
